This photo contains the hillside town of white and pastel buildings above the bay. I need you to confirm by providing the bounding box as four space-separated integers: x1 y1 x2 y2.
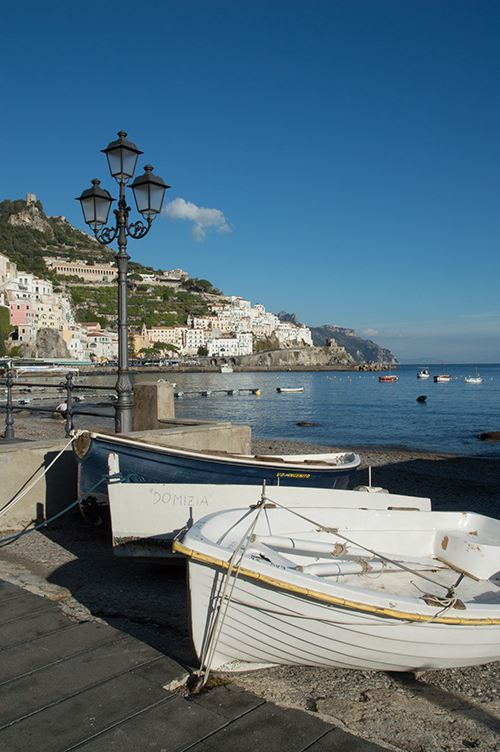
0 236 312 360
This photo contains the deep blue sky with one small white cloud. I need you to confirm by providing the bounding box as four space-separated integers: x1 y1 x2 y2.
0 0 500 364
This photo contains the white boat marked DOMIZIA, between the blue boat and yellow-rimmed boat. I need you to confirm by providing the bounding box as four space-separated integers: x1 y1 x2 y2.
108 453 431 558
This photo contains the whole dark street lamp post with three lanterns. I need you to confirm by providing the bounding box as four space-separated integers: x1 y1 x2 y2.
77 131 170 433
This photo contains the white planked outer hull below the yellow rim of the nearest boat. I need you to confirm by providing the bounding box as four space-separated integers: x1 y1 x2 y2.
189 561 500 671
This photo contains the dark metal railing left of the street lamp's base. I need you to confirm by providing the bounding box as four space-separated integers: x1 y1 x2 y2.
0 371 116 439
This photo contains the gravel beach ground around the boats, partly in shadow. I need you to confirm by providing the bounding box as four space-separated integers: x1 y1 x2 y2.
0 416 500 752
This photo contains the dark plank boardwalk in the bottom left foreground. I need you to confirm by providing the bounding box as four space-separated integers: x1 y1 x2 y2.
0 580 383 752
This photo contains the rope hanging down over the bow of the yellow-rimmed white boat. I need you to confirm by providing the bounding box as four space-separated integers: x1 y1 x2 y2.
191 481 267 694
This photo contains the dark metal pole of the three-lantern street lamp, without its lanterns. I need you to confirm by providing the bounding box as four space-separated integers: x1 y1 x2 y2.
115 180 134 433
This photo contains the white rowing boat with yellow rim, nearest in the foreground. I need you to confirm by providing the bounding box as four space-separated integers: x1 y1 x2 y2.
174 502 500 671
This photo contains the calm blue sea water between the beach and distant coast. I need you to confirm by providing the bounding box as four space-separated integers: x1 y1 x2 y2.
82 364 500 458
